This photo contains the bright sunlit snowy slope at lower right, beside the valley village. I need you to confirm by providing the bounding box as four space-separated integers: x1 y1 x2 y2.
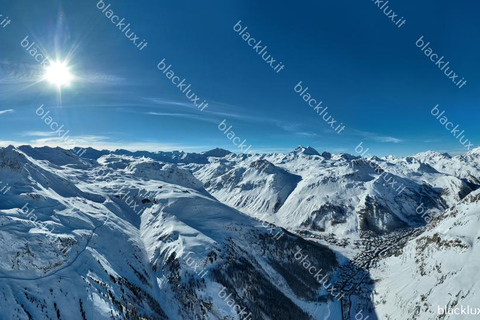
372 191 480 319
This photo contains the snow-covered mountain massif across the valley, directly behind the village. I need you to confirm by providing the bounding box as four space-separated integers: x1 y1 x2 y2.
191 147 472 236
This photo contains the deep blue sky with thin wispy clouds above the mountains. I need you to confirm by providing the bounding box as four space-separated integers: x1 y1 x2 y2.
0 0 480 155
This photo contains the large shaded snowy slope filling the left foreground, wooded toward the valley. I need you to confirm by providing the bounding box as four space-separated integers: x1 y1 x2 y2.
0 147 339 320
